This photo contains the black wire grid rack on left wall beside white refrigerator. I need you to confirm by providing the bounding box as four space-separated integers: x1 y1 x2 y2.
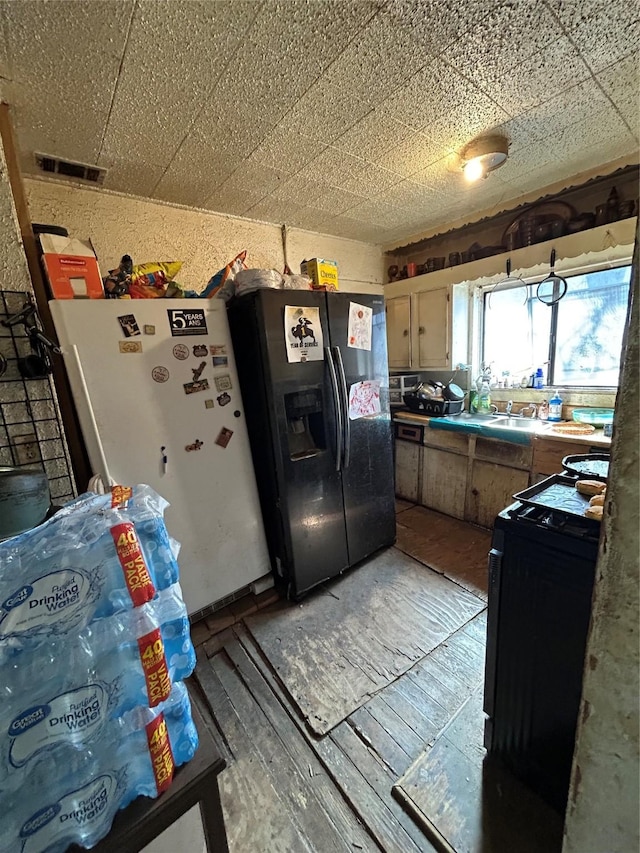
0 290 76 504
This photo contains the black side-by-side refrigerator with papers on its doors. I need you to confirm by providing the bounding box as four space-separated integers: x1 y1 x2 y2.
228 289 395 598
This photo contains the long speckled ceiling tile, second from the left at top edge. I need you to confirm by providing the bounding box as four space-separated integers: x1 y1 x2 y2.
99 0 260 195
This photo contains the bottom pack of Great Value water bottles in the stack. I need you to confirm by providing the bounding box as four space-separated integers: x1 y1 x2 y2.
0 684 198 853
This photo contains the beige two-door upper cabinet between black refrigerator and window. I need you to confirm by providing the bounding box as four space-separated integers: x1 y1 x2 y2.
386 285 469 370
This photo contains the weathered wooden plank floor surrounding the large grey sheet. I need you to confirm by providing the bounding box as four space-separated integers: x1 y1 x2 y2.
185 502 559 853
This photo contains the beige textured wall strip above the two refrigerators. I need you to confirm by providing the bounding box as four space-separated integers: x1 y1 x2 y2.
25 180 384 292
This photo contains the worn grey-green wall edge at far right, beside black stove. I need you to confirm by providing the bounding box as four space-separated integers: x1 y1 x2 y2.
563 230 640 853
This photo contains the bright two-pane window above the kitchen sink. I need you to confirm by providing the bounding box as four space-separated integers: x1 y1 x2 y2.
483 266 631 387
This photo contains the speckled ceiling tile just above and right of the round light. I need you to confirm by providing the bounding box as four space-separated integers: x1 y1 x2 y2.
492 36 591 116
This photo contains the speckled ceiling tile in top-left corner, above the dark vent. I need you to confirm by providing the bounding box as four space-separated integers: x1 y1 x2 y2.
3 0 133 172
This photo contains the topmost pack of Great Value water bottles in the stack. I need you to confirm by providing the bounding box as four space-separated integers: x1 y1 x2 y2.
0 486 179 649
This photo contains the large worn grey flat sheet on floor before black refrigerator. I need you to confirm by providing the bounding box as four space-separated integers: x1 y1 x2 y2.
246 548 484 734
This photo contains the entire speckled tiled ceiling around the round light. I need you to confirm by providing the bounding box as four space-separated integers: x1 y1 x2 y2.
0 0 640 242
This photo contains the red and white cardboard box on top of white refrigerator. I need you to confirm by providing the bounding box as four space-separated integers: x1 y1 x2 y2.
40 234 104 299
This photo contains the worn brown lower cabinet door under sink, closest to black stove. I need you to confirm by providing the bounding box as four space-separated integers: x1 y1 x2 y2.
465 459 529 529
